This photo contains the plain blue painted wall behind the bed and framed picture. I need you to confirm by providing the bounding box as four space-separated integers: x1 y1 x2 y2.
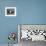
0 0 46 44
